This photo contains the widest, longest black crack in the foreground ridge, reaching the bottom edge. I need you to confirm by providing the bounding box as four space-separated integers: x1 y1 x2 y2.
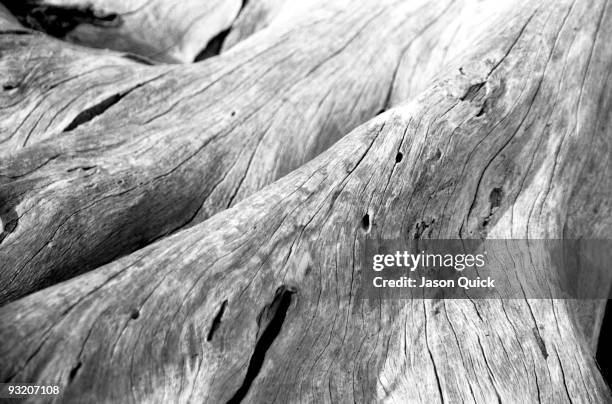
228 285 296 404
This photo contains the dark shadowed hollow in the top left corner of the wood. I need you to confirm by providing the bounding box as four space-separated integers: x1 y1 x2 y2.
2 0 123 38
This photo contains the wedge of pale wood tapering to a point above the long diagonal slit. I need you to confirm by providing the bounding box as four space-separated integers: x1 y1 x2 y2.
0 28 165 155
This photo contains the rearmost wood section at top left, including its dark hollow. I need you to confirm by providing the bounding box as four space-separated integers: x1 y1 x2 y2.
7 0 245 63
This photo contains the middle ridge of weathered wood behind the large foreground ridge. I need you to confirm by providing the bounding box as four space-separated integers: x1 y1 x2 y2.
0 0 466 301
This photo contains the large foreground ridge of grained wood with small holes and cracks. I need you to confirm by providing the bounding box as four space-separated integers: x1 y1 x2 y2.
0 0 612 403
